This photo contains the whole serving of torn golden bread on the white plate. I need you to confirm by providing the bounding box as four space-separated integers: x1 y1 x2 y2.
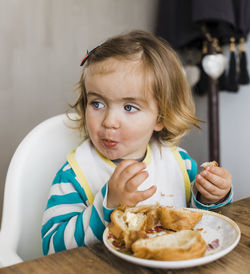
109 205 206 260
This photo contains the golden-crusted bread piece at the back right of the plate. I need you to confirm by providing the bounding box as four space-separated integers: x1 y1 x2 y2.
159 206 202 231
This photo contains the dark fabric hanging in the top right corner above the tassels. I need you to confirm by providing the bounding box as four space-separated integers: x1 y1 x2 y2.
155 0 250 49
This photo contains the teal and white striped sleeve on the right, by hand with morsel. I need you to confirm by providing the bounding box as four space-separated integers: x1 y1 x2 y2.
178 148 233 210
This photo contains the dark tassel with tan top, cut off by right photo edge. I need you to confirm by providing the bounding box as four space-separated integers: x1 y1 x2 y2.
238 37 249 85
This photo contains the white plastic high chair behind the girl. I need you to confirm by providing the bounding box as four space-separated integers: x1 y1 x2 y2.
0 114 81 267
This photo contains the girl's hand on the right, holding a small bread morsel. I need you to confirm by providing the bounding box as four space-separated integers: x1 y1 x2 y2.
195 166 232 204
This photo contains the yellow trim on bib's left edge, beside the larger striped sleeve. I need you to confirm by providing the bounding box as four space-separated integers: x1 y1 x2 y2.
67 149 94 205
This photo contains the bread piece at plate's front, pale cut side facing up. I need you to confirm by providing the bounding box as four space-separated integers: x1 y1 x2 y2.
132 230 206 261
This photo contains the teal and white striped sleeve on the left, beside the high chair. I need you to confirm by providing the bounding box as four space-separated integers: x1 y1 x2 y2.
41 162 112 255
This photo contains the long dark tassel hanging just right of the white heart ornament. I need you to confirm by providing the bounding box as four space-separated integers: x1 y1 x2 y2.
227 37 239 92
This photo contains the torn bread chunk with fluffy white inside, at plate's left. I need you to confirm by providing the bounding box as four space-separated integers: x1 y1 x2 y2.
109 205 159 249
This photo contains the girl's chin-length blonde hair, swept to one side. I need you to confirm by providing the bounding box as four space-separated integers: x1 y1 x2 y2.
71 31 199 144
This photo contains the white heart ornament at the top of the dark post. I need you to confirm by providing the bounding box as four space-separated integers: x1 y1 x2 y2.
202 53 226 80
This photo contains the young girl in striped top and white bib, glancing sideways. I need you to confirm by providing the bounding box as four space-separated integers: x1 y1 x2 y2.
42 31 232 254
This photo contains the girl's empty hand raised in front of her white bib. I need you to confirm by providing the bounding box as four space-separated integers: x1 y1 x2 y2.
107 160 156 208
